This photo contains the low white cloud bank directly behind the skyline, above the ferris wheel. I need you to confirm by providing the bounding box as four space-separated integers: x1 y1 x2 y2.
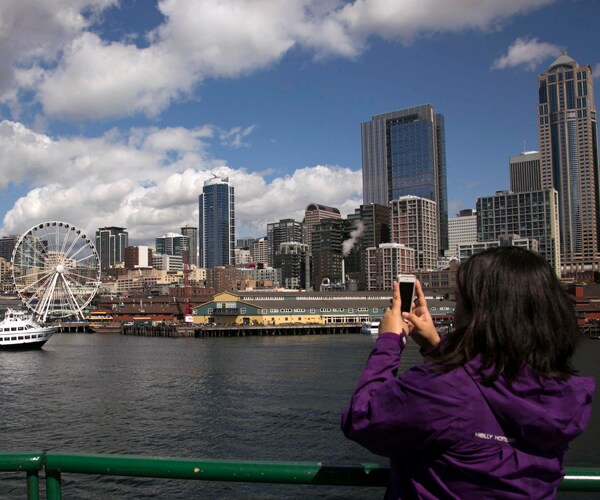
0 121 362 243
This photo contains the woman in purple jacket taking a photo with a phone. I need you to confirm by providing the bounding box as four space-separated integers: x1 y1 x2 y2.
342 247 594 499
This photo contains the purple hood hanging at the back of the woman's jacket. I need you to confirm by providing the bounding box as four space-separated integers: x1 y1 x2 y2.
464 357 595 450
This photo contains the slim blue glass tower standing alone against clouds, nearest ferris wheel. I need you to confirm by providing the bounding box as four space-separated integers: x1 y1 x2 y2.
198 177 235 268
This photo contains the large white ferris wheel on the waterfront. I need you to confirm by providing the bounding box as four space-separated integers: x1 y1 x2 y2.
12 221 100 321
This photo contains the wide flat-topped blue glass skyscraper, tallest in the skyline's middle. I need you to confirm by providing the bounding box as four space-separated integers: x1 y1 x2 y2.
361 104 448 252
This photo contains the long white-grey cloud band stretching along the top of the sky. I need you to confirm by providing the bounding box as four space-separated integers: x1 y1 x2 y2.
0 0 555 119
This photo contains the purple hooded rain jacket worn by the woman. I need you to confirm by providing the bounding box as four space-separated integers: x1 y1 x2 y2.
342 333 594 499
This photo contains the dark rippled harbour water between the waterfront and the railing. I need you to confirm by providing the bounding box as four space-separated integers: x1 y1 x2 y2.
0 334 600 499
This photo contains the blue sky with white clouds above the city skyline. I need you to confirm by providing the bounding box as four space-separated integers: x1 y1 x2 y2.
0 0 600 245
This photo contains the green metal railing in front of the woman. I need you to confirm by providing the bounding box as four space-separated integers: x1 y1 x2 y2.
0 452 600 500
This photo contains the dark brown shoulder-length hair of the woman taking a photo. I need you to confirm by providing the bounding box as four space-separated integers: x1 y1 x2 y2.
432 247 579 383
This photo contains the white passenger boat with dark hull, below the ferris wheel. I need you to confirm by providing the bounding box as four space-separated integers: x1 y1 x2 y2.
0 309 56 349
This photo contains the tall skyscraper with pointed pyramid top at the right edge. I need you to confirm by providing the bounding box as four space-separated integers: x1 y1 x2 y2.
538 53 600 272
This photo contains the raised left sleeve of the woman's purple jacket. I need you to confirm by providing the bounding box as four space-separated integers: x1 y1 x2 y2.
342 333 464 457
